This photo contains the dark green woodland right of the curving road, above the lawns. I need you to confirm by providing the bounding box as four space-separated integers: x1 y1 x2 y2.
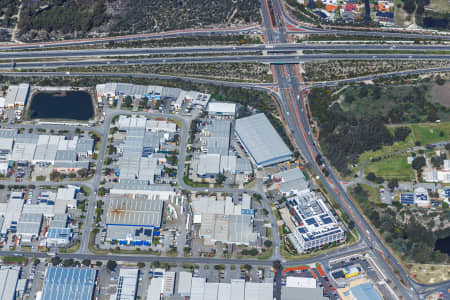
309 86 450 175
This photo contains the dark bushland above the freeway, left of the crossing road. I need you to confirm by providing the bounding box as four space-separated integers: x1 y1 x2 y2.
18 0 260 39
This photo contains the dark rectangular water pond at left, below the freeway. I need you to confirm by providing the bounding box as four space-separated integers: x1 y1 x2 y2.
30 91 94 121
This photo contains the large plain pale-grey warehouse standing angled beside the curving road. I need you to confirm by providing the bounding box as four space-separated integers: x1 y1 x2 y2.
234 113 292 167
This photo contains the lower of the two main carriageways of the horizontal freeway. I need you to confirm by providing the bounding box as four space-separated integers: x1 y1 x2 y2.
0 54 450 69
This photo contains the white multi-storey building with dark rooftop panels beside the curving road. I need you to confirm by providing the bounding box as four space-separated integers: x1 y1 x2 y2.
287 191 345 253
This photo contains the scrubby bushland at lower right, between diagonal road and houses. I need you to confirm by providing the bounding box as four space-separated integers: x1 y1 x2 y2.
350 185 450 263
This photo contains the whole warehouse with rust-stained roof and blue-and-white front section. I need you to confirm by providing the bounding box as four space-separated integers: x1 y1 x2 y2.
105 196 164 246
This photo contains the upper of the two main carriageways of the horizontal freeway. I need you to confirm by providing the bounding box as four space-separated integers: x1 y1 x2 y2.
0 43 450 59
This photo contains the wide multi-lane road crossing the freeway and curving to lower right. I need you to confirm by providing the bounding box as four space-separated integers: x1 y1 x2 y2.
262 0 448 299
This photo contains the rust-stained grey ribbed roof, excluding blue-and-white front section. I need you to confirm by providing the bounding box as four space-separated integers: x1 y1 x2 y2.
106 198 163 227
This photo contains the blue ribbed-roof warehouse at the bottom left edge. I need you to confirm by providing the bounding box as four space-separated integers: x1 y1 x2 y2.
41 267 97 300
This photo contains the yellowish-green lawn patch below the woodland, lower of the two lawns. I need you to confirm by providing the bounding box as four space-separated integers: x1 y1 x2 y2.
364 155 414 181
